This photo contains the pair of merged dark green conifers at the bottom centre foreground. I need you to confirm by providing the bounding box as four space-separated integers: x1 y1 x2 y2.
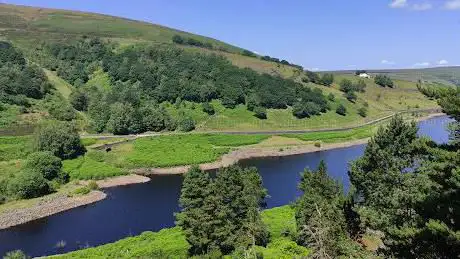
176 166 269 258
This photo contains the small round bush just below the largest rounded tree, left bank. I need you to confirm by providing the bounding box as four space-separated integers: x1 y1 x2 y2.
24 151 63 181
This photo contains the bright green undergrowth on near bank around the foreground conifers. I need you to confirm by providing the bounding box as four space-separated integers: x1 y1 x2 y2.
50 206 309 259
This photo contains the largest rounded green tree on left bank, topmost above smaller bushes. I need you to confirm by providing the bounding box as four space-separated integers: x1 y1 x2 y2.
34 121 86 159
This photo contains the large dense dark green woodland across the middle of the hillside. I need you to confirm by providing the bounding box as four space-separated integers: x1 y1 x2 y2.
45 39 329 134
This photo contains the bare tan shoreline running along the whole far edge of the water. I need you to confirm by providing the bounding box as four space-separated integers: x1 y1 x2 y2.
0 113 445 230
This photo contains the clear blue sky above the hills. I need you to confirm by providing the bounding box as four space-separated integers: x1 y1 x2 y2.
3 0 460 70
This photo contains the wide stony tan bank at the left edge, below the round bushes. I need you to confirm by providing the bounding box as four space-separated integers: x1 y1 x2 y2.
0 191 107 230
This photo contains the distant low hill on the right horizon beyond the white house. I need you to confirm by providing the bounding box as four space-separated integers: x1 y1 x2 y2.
331 66 460 86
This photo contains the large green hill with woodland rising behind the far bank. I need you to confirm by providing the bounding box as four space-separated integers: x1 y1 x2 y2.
0 4 437 137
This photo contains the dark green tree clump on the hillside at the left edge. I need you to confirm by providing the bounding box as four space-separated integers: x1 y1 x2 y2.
0 41 51 107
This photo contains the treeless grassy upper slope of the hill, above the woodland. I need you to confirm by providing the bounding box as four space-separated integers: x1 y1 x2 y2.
0 4 241 52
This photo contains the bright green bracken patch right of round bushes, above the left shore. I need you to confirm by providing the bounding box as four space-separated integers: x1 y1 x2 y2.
63 151 127 180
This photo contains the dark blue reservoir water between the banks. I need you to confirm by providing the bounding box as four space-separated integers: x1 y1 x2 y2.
0 117 450 256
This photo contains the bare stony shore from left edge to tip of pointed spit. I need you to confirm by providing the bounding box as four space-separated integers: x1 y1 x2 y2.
0 175 151 230
